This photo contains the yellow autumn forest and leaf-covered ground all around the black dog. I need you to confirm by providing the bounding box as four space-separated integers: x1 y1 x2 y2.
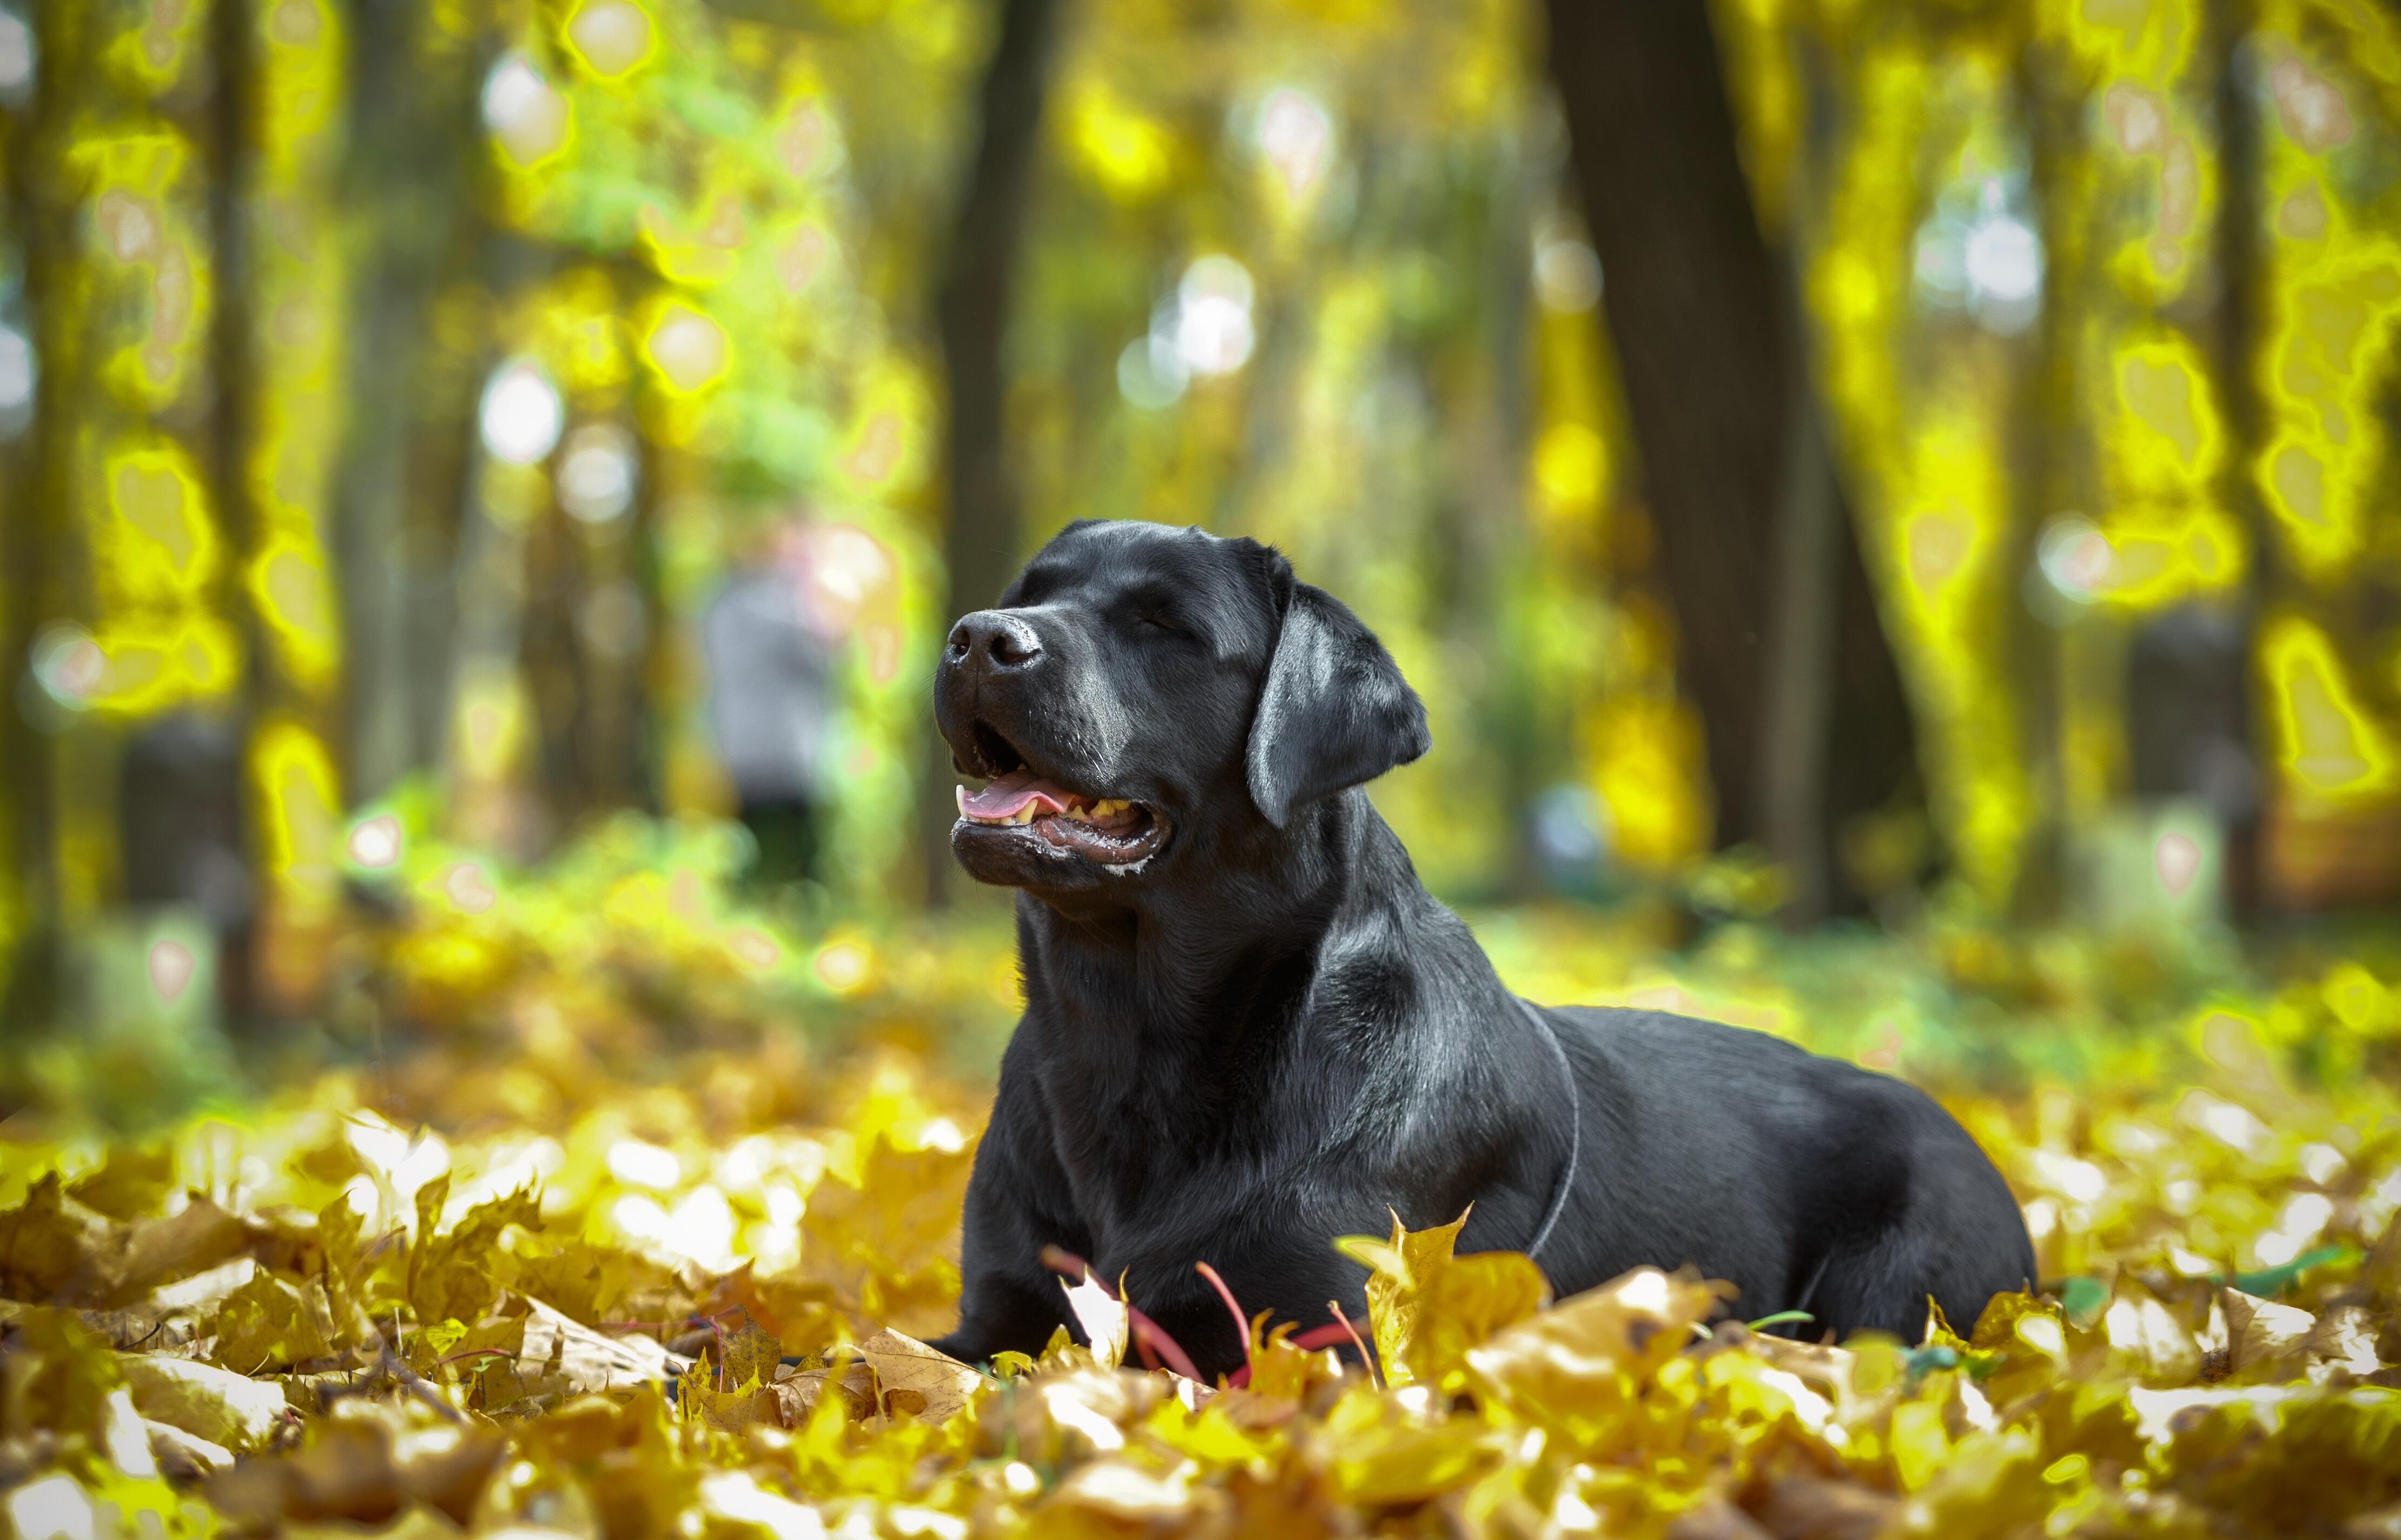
0 0 2401 1540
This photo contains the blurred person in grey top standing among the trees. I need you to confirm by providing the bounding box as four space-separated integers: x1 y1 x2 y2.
701 518 845 882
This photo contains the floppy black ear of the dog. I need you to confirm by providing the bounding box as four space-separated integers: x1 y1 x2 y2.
1244 583 1433 827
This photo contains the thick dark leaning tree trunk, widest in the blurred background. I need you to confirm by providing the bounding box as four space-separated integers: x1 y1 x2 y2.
1546 0 1914 912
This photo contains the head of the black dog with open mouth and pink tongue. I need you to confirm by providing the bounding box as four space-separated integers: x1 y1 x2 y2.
934 521 1428 895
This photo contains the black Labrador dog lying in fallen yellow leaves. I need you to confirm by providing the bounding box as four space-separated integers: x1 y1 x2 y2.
934 523 2034 1375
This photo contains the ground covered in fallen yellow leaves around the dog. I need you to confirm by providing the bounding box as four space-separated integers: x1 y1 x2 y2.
0 835 2401 1540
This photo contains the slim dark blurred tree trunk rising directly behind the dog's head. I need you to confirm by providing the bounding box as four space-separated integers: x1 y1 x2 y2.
927 0 1059 902
